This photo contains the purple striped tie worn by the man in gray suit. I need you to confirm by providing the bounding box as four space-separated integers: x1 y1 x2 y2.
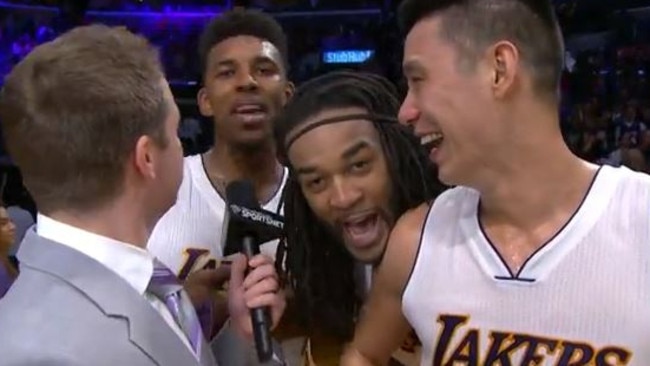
147 259 203 355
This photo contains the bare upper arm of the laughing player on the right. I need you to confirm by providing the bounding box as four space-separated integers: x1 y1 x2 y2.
341 205 429 366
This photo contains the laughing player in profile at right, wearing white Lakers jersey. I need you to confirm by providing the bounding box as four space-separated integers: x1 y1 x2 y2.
341 0 650 366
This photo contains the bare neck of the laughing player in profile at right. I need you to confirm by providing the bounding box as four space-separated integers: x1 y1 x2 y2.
474 103 596 230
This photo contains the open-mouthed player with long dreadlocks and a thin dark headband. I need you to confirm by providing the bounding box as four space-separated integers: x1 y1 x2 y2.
275 71 443 366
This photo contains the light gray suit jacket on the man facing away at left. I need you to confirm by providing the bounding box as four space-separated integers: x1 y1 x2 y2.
0 229 215 366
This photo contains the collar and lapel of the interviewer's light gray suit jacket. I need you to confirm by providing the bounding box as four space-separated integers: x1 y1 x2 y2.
18 229 212 366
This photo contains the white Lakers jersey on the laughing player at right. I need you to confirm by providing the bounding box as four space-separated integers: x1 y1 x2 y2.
402 166 650 366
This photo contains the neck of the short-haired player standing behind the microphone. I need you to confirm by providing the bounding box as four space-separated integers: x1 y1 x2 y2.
204 142 283 202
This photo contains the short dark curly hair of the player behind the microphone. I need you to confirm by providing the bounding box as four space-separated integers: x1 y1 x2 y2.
199 8 289 75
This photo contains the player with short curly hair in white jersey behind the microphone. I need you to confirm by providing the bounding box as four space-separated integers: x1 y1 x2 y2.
148 9 293 366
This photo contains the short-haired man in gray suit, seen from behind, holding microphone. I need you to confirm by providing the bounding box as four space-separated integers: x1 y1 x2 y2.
0 25 283 366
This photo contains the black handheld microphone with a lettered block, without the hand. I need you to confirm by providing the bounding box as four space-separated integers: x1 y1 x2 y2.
221 181 284 363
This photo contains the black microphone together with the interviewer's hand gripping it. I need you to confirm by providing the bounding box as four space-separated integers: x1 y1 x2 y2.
222 181 285 363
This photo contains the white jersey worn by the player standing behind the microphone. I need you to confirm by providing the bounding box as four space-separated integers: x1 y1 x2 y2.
147 155 288 278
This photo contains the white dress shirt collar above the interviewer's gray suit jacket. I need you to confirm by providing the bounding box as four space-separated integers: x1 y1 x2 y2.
36 213 154 295
